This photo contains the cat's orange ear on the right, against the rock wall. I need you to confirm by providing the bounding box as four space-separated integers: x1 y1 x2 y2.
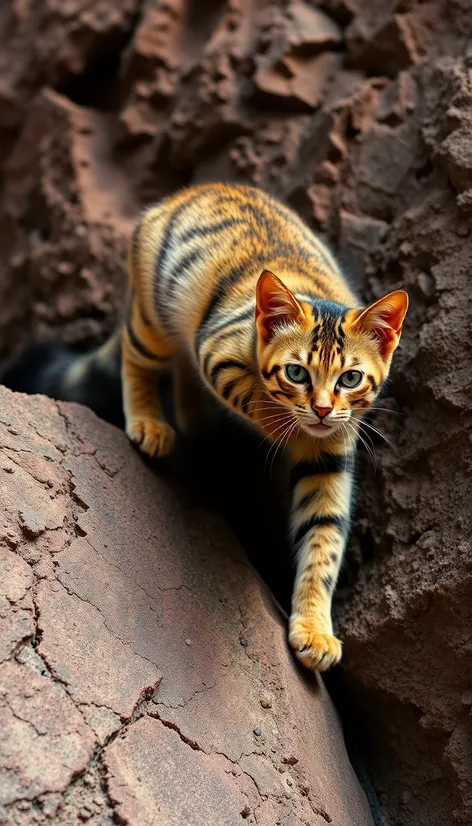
352 290 408 358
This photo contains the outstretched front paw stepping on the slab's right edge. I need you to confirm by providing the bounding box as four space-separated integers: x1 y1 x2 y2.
288 616 342 671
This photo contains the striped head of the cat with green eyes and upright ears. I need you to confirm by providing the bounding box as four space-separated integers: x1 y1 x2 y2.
256 270 408 438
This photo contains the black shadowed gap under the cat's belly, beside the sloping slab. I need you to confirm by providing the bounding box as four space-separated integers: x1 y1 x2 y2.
157 377 294 613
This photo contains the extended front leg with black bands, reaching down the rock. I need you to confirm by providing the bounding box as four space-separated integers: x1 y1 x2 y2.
289 444 352 671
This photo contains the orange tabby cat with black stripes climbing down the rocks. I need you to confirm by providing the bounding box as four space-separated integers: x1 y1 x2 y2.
0 183 408 671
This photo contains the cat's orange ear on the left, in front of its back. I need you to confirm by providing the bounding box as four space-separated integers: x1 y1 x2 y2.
256 270 304 343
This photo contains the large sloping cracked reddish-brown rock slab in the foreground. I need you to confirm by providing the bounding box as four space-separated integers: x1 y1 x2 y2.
0 389 372 826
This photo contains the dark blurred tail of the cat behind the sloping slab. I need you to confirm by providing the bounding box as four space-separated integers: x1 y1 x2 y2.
0 330 124 427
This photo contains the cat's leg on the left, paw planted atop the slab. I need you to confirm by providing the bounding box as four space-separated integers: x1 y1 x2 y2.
121 299 175 456
